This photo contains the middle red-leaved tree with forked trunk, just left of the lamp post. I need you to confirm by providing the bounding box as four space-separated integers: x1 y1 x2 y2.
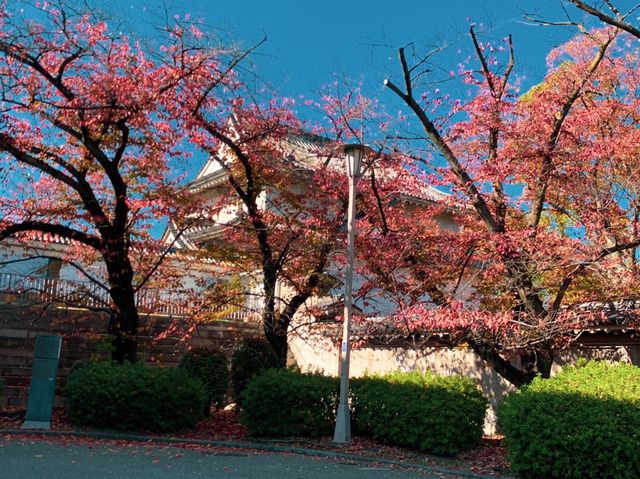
166 61 420 366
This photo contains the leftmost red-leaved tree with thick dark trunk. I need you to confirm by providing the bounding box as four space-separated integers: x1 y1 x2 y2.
0 1 218 362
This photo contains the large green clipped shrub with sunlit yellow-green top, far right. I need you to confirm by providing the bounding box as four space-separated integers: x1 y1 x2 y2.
498 361 640 479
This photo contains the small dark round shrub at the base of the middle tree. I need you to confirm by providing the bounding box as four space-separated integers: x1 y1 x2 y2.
231 338 278 404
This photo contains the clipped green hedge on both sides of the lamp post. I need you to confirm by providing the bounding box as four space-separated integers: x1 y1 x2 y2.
241 369 487 455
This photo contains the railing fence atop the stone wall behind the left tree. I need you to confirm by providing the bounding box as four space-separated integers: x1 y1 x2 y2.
0 273 251 320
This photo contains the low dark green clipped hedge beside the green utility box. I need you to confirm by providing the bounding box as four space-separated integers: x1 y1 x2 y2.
64 362 207 432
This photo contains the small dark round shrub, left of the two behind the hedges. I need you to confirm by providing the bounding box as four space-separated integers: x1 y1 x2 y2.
178 348 229 407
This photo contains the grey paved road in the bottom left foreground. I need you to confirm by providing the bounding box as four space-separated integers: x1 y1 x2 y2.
0 439 470 479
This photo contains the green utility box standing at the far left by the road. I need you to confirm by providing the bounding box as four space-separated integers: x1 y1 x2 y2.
22 336 62 429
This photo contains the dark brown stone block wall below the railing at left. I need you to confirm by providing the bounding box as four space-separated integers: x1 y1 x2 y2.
0 302 260 408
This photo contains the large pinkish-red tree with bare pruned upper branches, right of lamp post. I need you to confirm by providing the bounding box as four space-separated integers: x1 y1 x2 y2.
378 24 640 386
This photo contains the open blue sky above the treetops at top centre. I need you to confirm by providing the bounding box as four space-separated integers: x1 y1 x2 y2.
106 0 604 96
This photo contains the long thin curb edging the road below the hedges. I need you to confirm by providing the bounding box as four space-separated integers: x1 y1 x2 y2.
0 429 512 479
